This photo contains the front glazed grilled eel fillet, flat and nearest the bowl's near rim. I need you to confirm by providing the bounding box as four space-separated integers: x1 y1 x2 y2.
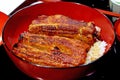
13 32 90 67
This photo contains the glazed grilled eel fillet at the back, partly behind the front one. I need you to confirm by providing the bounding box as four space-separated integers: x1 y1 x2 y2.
28 15 96 45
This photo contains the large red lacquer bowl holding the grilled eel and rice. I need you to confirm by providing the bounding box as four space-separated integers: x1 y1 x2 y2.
3 2 115 80
